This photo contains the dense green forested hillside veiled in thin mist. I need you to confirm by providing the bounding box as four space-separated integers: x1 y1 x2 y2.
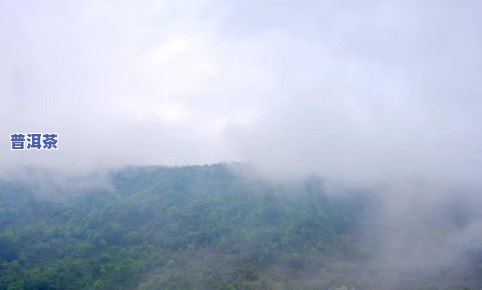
0 164 480 290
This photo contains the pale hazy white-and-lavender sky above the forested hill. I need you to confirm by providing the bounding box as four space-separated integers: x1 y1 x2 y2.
0 0 482 184
